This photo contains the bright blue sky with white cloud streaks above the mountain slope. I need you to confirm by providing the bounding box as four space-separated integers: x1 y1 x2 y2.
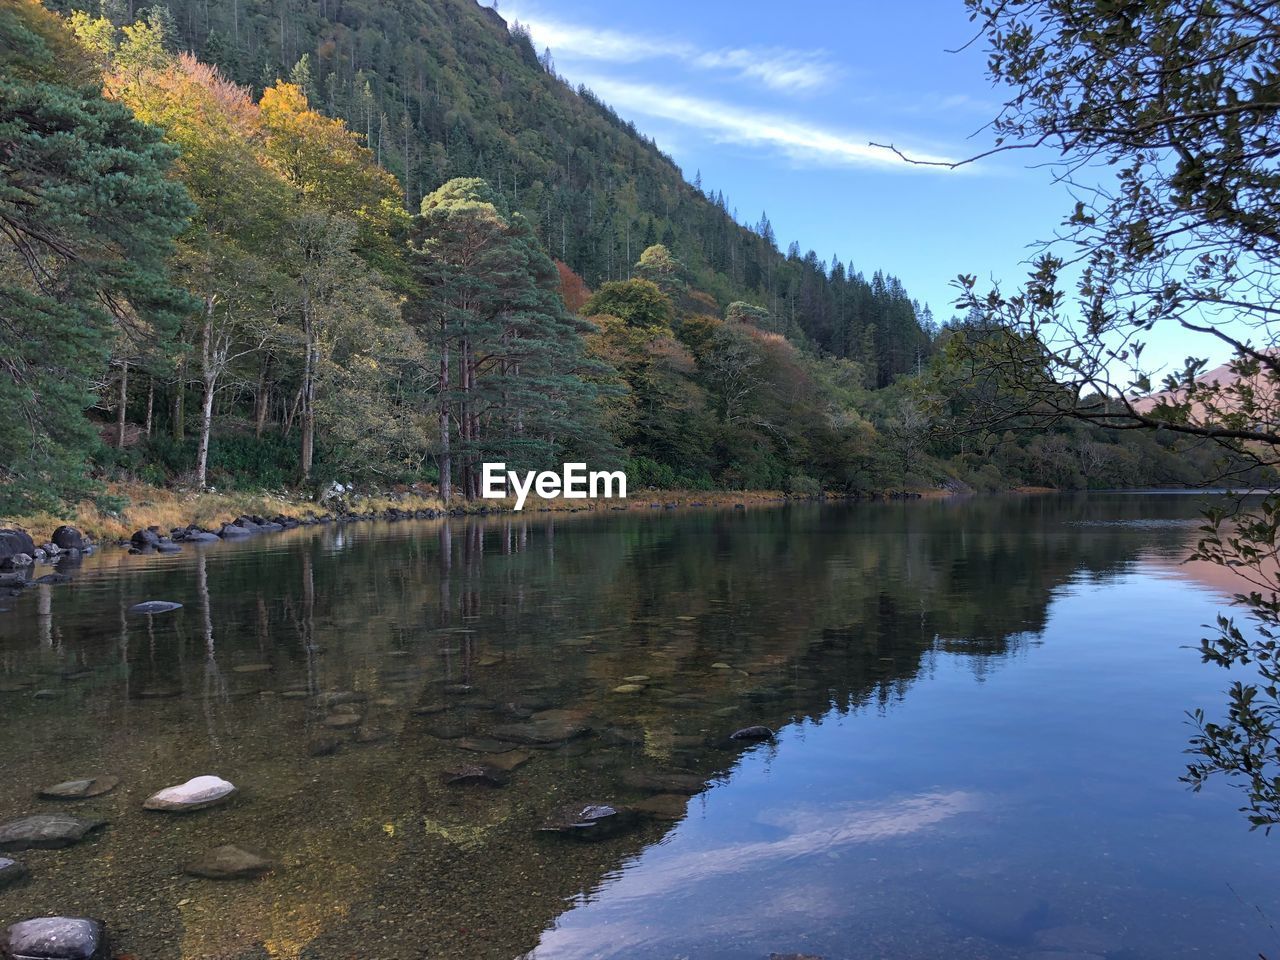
498 0 1224 376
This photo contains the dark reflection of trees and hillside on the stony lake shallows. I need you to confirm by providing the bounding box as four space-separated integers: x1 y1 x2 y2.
0 499 1198 957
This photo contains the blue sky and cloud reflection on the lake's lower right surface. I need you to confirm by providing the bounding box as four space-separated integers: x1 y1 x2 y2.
531 570 1277 960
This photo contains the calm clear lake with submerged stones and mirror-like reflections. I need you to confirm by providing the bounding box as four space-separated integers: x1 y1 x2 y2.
0 494 1280 960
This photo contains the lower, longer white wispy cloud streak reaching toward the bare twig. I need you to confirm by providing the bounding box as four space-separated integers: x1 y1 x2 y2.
586 77 951 170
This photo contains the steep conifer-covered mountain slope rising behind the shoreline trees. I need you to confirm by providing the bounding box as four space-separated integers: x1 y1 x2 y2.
51 0 932 385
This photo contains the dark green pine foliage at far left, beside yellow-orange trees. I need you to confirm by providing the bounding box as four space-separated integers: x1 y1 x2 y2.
0 0 191 512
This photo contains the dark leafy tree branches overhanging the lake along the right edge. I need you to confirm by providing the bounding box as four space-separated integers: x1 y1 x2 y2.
916 0 1280 826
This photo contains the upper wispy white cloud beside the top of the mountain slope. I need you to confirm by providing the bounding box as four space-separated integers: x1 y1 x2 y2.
504 8 842 93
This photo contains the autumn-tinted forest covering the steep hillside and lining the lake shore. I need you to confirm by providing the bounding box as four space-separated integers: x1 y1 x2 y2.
0 0 1264 513
